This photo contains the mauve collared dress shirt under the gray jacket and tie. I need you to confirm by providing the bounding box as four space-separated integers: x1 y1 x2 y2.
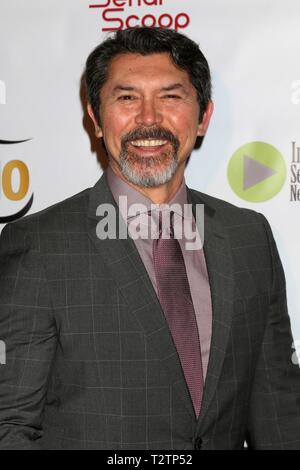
105 167 212 380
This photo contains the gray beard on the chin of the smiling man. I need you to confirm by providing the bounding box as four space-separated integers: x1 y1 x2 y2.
119 148 178 188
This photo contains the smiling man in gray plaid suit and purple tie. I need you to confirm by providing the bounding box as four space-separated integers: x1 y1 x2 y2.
0 28 300 450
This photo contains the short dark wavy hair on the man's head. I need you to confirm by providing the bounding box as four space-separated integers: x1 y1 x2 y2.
84 27 211 122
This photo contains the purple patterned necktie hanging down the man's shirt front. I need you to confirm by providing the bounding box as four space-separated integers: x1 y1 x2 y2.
153 212 203 416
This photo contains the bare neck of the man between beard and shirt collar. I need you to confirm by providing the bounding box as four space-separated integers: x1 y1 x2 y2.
110 165 184 204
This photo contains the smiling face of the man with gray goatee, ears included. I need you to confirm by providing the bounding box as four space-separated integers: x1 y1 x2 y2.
89 54 212 187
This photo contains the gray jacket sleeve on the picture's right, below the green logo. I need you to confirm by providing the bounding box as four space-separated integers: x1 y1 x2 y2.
248 215 300 450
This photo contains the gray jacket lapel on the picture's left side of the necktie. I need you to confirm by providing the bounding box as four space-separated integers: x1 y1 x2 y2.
88 174 195 418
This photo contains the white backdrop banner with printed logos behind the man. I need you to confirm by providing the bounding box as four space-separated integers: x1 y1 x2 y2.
0 0 300 361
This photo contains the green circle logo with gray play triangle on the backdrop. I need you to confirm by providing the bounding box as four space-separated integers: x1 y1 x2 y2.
227 142 286 202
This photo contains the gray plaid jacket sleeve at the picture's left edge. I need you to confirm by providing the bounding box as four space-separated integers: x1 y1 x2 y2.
0 221 57 449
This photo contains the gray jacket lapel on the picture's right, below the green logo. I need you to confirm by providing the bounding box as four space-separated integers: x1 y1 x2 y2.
188 190 234 427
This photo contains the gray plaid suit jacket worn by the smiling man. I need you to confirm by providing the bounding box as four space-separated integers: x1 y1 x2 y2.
0 172 300 450
